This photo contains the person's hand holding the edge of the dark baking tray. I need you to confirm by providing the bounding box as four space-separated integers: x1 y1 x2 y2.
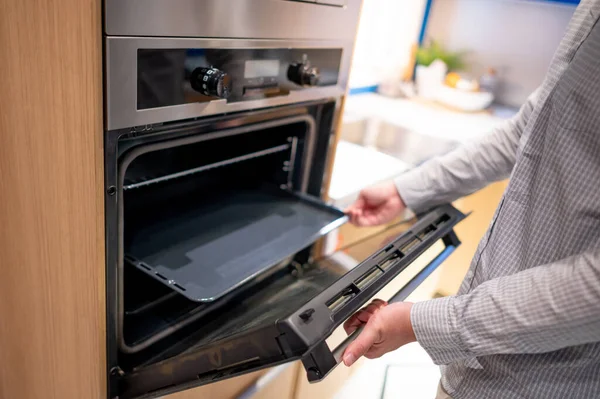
346 182 406 227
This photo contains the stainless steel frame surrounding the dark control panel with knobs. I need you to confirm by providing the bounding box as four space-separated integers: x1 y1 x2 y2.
105 37 353 130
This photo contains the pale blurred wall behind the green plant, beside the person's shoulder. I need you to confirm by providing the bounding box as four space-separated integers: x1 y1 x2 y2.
426 0 575 106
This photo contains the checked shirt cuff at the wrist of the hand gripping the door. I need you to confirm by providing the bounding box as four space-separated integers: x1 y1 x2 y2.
410 296 470 365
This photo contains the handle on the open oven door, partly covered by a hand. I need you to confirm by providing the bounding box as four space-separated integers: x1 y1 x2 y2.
302 244 456 383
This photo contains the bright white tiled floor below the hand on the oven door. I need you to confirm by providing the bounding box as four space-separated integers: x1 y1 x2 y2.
335 343 440 399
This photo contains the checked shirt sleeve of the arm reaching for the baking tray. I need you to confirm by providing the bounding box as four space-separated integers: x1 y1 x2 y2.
395 90 539 213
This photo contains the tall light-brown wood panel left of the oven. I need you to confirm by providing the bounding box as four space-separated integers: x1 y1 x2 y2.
0 0 106 399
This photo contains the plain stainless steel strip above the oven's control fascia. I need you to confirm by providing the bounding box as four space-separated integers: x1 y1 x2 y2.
104 0 362 40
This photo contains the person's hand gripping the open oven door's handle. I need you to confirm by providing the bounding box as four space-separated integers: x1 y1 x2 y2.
343 299 417 367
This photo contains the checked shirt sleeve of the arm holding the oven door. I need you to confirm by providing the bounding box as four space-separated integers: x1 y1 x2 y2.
411 249 600 364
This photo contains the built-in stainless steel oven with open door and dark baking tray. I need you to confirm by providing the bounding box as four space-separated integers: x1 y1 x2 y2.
104 0 464 398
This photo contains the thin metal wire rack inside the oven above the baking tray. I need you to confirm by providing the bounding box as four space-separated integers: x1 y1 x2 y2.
123 143 298 190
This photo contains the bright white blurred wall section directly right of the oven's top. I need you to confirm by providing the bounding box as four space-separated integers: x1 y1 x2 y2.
350 0 425 87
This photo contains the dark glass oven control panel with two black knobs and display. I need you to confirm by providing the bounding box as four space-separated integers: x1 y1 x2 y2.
137 48 342 110
